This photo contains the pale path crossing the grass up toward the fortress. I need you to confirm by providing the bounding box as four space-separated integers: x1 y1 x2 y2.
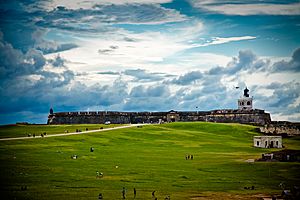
0 124 148 141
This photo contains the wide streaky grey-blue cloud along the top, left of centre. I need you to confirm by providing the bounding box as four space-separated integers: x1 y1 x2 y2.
36 4 187 33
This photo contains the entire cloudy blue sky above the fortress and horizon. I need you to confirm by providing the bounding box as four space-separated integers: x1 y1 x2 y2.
0 0 300 124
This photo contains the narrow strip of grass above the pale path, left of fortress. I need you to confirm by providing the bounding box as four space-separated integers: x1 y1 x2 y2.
0 124 121 138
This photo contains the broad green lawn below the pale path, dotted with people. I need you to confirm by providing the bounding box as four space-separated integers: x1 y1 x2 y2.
0 122 300 200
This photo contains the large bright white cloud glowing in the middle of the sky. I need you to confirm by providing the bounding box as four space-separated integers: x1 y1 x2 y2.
47 21 206 76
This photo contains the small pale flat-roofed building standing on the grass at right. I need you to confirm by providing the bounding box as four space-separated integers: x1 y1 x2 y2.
253 136 282 148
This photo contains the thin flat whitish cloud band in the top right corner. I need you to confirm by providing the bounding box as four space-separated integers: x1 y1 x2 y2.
191 0 300 16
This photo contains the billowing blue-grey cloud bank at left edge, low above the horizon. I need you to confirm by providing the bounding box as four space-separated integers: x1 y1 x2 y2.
0 32 74 114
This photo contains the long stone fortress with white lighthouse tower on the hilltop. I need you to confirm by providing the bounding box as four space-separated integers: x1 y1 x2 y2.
47 88 271 126
